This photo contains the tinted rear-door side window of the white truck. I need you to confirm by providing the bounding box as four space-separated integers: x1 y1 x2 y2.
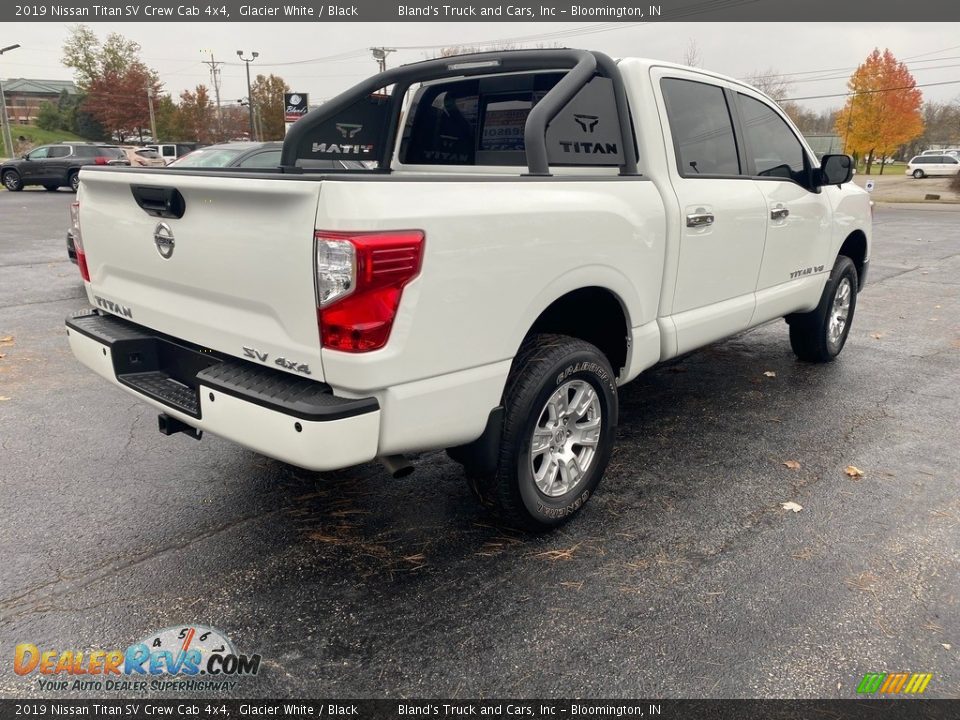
661 78 740 177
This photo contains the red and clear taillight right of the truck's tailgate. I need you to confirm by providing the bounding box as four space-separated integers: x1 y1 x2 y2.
314 230 424 353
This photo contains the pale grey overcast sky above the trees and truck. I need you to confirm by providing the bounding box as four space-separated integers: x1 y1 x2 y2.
0 22 960 110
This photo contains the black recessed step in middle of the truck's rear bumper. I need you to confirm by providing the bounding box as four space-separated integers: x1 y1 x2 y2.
111 337 221 418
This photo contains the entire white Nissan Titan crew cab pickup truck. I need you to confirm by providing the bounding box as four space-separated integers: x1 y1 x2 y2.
67 50 871 529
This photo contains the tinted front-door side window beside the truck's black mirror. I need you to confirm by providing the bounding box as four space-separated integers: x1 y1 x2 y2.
737 93 806 181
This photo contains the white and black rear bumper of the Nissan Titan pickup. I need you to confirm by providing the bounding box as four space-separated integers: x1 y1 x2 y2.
66 311 380 470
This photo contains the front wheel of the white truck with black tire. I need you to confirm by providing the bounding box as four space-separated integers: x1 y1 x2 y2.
787 255 858 363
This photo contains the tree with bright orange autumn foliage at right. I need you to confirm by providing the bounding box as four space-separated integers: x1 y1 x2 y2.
837 49 923 175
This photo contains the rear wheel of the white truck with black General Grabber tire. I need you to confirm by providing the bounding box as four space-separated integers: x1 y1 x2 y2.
466 335 618 531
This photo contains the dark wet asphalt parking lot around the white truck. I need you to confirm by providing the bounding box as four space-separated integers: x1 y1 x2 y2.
0 190 960 698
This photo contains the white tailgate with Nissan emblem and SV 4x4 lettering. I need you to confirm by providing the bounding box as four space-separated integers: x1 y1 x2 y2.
78 170 323 380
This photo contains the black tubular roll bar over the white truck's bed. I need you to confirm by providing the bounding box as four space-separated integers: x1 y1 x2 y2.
280 49 637 175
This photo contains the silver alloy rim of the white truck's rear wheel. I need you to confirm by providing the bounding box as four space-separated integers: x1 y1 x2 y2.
530 380 603 497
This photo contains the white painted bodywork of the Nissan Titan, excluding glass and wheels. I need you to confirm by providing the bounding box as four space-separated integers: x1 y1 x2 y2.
71 53 870 478
